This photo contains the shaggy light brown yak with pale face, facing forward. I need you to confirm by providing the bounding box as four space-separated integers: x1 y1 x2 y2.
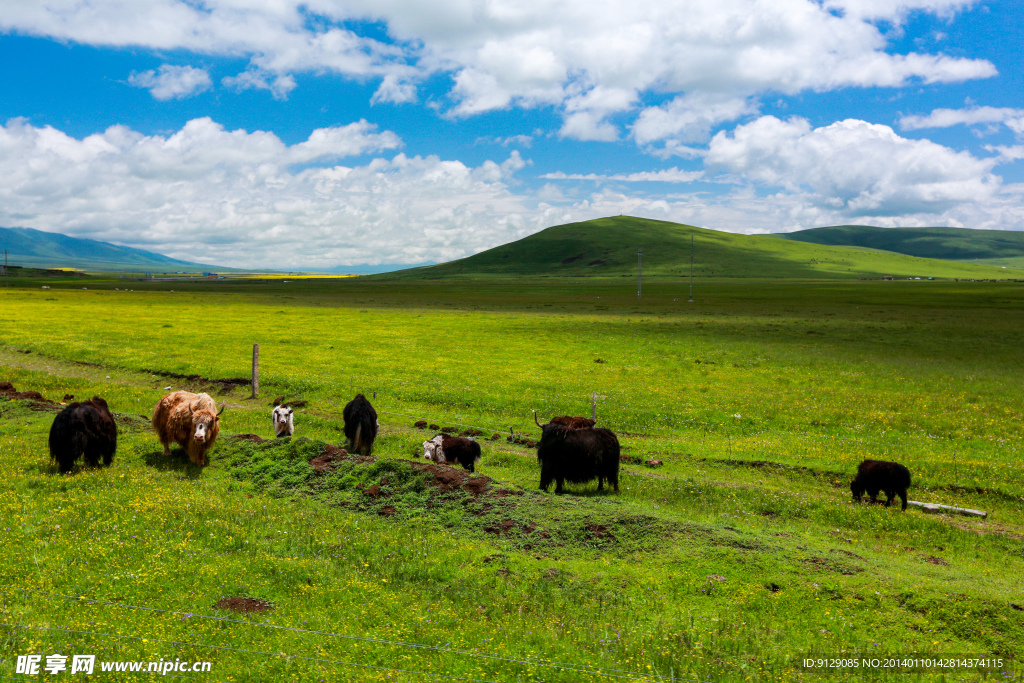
153 391 224 467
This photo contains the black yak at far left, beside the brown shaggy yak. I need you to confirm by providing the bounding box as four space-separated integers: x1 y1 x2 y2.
50 396 118 473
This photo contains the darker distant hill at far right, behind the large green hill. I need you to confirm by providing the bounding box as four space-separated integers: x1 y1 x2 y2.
772 225 1024 268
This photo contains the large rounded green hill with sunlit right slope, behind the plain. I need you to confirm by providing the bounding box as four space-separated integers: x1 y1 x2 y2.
376 216 1024 280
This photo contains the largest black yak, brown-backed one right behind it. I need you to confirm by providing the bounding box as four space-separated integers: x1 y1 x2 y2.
537 423 620 494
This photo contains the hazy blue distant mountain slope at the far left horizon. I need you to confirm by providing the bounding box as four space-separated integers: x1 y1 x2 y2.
0 227 227 272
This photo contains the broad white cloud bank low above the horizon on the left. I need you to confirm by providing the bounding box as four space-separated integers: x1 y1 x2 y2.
0 119 543 268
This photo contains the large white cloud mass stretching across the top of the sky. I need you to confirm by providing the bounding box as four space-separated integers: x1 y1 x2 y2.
0 0 996 141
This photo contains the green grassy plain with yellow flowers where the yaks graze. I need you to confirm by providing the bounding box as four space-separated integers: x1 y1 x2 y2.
0 278 1024 681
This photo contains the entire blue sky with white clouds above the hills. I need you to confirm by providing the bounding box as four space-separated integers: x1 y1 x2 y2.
0 0 1024 268
